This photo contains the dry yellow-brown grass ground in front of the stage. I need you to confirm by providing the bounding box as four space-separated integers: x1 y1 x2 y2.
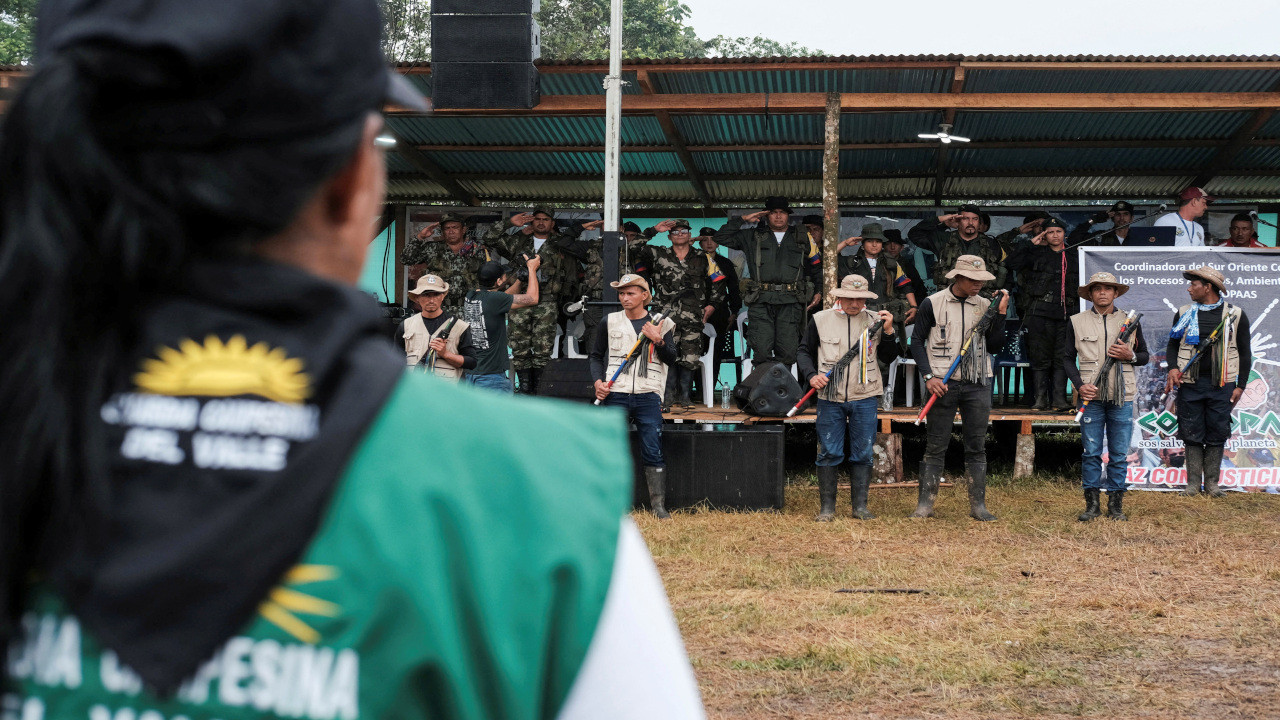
636 461 1280 719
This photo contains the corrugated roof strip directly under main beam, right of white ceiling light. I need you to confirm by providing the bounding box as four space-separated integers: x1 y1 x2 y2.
952 111 1249 141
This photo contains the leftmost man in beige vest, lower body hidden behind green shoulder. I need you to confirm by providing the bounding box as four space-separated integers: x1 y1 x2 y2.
399 275 476 380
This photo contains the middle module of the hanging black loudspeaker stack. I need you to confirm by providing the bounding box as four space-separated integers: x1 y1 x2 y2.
431 14 539 62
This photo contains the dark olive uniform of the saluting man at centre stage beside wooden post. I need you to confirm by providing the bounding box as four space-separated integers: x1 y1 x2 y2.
716 218 822 365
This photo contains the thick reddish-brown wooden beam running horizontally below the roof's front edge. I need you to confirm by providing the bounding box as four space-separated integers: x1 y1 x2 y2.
389 92 1280 117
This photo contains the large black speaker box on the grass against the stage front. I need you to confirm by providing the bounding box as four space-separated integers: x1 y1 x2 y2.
631 423 786 510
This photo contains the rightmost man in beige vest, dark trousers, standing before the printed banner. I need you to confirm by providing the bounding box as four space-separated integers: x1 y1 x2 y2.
1165 265 1253 497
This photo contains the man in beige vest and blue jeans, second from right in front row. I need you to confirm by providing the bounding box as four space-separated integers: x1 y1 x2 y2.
1060 273 1149 523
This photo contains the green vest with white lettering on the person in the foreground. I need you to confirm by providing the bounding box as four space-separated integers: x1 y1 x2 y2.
4 374 632 720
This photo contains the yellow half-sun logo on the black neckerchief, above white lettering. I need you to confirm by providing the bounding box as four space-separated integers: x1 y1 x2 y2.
133 334 311 402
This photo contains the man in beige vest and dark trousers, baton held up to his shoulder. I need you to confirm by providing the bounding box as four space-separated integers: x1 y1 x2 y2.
911 255 1009 520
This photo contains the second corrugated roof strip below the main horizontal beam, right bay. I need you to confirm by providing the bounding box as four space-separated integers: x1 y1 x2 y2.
947 147 1217 173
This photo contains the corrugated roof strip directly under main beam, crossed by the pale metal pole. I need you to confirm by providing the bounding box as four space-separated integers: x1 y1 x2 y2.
387 115 667 146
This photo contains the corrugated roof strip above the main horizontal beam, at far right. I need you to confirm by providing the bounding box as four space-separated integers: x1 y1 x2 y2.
964 68 1280 94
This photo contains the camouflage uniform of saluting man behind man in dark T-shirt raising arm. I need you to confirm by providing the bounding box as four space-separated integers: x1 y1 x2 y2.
481 219 577 373
